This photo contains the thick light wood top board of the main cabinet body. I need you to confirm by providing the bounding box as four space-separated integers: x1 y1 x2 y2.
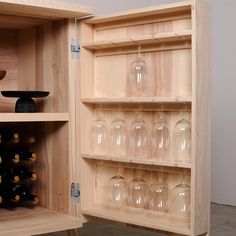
0 0 94 18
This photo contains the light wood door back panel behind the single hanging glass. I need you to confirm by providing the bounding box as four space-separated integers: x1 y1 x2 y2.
94 49 191 98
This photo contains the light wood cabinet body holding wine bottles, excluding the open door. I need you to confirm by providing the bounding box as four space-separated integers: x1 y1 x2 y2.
0 0 93 236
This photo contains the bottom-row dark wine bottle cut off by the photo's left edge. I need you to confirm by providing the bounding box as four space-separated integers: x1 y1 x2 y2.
0 185 20 207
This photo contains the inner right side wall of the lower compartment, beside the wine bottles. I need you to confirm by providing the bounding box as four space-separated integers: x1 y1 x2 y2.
34 122 70 213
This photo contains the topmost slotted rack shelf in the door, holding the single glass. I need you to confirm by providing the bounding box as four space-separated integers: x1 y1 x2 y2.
83 30 192 50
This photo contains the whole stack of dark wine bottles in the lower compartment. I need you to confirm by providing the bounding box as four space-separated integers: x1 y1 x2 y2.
0 127 39 208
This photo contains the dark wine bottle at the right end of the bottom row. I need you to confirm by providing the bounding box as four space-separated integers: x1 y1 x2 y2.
12 185 39 205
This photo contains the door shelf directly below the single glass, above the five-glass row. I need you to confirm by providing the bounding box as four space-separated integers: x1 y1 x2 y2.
81 97 192 104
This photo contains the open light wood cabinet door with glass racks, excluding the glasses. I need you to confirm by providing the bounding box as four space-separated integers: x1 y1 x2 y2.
77 0 210 235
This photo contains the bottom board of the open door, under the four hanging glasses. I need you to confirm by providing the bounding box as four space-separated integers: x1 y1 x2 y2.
82 205 190 235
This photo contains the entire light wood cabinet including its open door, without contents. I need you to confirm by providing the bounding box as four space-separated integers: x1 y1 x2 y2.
0 0 211 236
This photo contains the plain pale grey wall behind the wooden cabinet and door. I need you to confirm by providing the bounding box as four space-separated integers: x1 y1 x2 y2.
68 0 236 206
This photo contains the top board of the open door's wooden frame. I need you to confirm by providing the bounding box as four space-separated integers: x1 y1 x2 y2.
85 1 192 24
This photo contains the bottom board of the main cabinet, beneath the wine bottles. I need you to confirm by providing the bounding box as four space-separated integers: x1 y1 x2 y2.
0 207 82 236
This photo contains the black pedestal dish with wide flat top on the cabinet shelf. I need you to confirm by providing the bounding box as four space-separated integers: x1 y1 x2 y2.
1 91 49 113
